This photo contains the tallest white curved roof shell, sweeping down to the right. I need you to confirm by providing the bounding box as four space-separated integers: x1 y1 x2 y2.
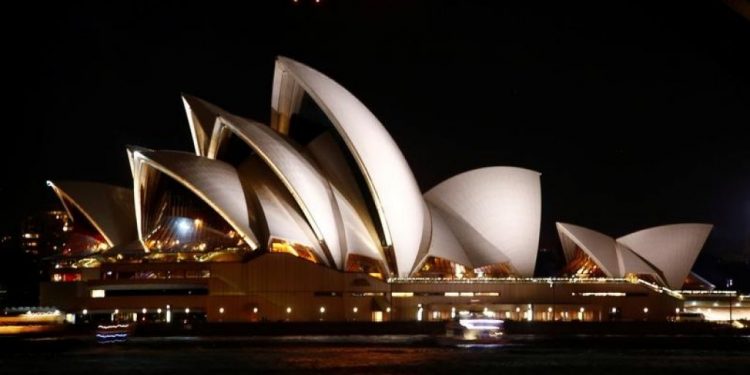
271 57 430 277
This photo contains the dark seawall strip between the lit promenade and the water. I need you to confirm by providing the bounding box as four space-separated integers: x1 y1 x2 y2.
0 321 750 339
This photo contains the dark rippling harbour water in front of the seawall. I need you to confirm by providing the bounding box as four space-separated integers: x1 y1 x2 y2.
0 335 750 375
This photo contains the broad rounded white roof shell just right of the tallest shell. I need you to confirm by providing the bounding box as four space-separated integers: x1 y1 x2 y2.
425 167 542 277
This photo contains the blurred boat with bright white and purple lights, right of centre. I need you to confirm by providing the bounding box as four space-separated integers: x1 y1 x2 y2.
439 314 505 344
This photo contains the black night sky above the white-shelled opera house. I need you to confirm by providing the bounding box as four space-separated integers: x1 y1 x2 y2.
0 0 750 262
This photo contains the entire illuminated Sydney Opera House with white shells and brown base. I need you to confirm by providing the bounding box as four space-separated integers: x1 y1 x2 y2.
36 57 736 321
